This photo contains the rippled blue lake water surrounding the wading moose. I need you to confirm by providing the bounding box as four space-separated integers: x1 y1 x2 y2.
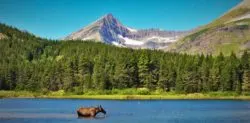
0 99 250 123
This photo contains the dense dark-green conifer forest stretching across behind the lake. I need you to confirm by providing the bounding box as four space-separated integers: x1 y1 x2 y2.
0 24 250 94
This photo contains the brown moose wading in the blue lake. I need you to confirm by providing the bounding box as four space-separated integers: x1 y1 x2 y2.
77 105 106 118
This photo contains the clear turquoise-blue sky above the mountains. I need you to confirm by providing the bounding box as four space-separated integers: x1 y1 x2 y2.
0 0 241 39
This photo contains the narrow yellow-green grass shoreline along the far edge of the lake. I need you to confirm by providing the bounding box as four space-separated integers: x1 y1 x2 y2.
0 91 250 100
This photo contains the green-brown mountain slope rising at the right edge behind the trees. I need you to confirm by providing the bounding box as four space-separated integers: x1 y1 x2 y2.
167 0 250 55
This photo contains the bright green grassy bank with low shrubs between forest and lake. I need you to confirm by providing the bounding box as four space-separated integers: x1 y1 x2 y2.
0 91 250 100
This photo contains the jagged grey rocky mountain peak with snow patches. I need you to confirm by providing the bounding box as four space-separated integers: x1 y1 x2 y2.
65 14 188 49
